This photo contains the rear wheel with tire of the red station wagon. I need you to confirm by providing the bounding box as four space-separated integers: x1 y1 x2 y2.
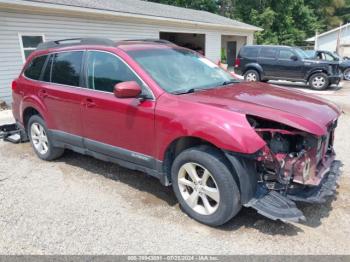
27 115 64 161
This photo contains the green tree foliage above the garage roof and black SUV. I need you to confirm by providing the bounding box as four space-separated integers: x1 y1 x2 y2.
146 0 350 45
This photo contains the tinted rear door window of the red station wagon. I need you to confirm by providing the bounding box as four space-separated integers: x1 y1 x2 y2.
51 51 83 86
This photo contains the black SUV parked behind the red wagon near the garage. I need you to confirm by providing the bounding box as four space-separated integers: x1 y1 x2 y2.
235 45 341 90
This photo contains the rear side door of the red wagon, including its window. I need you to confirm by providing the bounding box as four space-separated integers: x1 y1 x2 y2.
37 51 84 146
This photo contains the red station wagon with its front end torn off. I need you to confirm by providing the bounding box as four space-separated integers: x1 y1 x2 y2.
12 38 341 226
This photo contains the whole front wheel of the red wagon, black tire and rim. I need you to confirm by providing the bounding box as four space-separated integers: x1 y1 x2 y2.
171 146 242 226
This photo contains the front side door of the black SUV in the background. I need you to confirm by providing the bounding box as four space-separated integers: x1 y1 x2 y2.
278 48 304 80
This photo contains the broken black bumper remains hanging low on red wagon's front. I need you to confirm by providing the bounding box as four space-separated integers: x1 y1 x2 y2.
245 161 342 222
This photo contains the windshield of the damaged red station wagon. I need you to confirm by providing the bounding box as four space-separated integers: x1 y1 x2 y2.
128 49 239 94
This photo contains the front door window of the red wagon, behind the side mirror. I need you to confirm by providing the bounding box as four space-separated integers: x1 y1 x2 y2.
87 51 142 92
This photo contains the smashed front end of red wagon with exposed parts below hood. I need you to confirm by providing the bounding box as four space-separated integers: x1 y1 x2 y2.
245 116 341 222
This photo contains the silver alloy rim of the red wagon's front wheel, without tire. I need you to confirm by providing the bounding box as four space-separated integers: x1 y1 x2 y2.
177 163 220 215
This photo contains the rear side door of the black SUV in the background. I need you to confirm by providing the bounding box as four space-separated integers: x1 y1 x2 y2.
258 46 280 77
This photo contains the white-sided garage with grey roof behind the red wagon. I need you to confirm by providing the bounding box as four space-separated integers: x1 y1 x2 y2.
0 0 261 102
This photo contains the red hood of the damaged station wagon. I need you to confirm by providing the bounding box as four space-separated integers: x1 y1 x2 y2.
182 82 340 136
